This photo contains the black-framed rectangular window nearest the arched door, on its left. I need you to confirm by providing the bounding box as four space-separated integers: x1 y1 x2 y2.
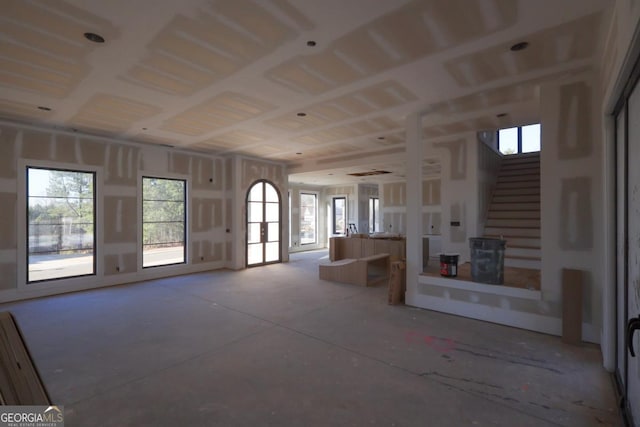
142 177 187 267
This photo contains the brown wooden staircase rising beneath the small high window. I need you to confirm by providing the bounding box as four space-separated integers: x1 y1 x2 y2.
484 153 541 270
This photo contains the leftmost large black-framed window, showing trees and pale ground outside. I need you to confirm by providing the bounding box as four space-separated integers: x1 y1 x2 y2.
26 167 96 283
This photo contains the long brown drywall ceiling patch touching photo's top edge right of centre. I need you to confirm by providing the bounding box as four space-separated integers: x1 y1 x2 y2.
266 0 517 94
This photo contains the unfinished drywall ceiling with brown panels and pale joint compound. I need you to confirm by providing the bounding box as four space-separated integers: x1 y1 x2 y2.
0 0 612 185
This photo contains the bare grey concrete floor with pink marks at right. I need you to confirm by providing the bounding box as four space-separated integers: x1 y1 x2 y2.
0 251 622 427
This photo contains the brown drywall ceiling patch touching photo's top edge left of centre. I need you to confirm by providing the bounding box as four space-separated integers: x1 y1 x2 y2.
120 0 308 96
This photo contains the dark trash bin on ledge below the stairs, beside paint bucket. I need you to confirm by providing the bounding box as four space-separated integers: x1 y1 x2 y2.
469 237 507 285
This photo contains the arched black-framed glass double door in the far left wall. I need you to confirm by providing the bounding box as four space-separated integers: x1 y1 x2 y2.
246 180 282 267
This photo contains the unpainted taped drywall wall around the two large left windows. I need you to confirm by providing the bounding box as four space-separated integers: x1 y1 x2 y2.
0 122 227 301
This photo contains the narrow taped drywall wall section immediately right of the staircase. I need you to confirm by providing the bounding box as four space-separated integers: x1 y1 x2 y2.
540 74 604 338
